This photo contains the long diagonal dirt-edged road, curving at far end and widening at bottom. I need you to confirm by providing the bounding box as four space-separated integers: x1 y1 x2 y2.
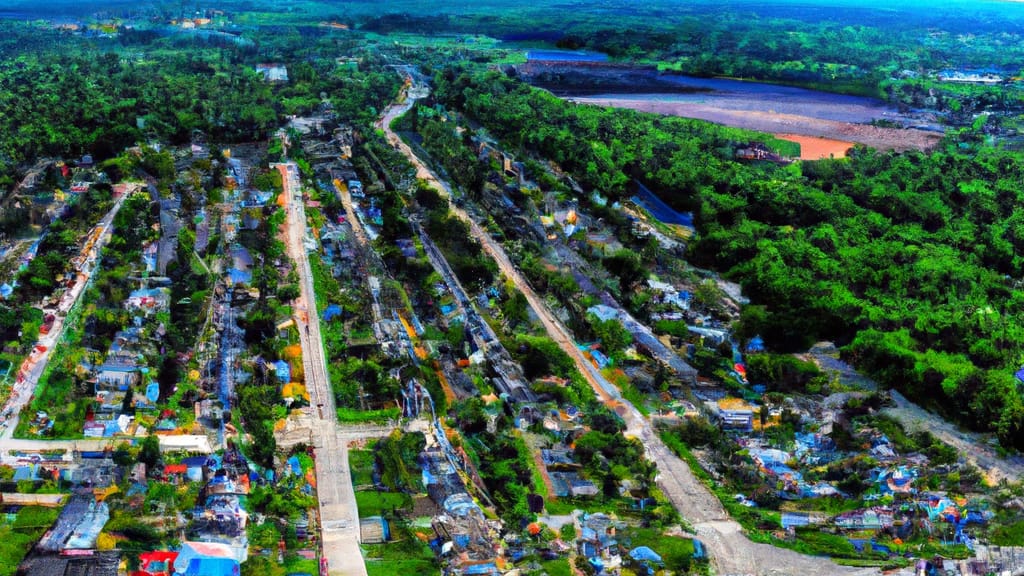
379 79 879 576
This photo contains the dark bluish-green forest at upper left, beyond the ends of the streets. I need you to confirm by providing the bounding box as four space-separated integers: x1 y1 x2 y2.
0 25 400 188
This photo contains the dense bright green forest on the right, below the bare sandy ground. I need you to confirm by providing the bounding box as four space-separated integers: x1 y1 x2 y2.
436 70 1024 447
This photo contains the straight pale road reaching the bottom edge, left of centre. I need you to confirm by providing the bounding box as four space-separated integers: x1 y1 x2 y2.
278 163 367 576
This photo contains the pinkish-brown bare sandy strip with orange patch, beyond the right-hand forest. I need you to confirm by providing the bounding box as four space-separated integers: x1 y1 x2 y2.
569 96 942 153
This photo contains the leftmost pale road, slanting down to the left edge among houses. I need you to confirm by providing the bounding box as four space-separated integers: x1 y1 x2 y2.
0 193 131 439
